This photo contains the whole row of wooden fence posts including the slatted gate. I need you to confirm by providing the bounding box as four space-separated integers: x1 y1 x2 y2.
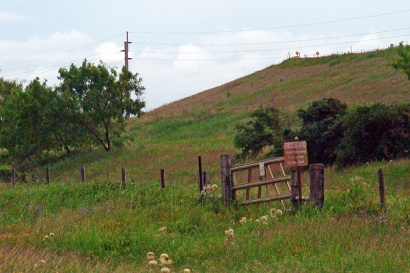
4 155 386 209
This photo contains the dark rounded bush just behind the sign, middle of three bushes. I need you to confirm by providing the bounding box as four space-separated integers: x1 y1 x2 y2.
298 98 347 165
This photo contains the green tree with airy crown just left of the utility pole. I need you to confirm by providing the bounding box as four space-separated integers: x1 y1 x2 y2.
58 60 145 151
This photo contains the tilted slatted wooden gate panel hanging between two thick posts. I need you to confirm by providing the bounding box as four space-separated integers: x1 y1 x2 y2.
221 157 292 208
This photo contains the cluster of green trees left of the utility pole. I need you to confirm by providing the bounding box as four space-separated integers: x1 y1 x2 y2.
0 60 145 169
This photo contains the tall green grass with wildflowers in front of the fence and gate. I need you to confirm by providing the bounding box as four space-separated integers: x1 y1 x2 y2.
0 157 410 272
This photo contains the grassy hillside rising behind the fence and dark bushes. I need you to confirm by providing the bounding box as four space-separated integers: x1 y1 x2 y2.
41 46 410 183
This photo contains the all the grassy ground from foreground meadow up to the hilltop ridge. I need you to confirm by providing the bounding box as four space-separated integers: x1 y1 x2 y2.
0 46 410 272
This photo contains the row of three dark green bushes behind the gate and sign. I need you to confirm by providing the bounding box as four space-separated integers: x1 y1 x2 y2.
235 98 410 168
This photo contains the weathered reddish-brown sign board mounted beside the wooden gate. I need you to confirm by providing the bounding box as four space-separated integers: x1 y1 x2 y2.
283 141 308 167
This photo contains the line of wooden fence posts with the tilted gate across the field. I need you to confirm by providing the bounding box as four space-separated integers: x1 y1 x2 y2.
2 155 390 207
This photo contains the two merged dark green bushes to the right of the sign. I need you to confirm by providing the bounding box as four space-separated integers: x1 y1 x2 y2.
298 99 410 167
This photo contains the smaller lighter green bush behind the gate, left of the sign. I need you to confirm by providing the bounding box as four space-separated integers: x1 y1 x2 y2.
234 108 282 157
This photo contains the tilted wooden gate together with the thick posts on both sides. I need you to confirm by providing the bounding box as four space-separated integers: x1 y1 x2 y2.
220 155 324 209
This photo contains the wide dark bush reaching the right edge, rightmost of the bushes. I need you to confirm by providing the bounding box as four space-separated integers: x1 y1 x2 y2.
336 104 410 167
